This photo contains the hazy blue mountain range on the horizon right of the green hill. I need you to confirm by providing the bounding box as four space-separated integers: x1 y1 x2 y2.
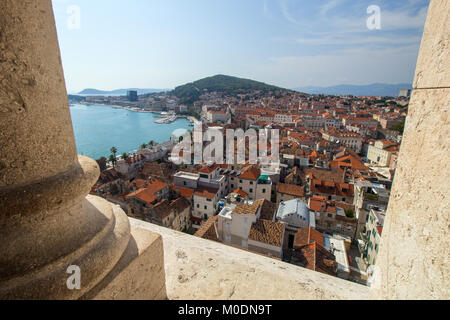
294 83 412 97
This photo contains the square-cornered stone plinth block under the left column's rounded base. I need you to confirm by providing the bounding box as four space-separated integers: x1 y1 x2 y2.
83 221 166 300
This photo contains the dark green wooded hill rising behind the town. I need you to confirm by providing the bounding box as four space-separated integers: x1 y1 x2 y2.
172 75 287 104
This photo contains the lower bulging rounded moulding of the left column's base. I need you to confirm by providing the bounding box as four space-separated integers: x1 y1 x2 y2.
0 196 130 299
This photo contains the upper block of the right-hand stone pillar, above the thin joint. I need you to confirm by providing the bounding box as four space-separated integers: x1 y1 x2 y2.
413 0 450 89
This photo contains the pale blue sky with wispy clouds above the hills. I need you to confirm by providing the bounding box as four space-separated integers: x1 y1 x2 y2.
53 0 429 92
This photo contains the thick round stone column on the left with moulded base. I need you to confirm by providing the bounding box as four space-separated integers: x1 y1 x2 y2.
0 0 164 299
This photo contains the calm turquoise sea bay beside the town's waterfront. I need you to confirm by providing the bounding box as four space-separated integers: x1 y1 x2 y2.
70 104 190 159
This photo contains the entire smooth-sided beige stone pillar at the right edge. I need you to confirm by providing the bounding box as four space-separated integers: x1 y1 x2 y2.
371 0 450 299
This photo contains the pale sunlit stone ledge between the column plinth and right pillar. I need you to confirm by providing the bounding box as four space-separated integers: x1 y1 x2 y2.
130 219 369 300
